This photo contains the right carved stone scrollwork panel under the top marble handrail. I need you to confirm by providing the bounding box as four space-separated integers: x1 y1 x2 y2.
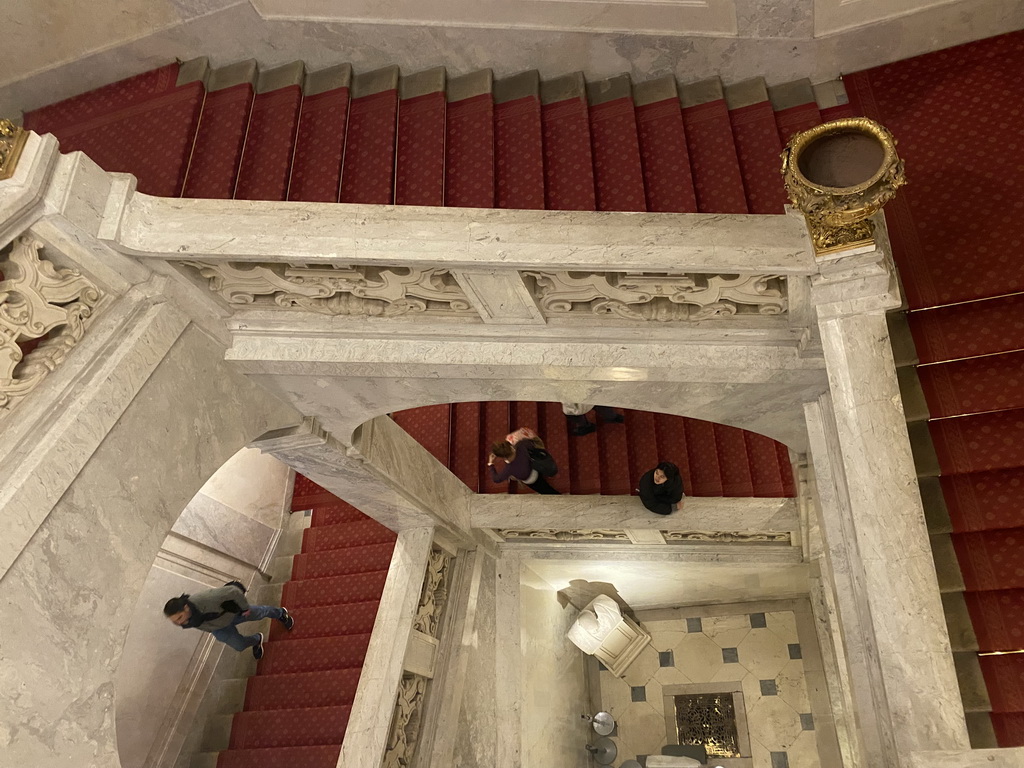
523 271 787 323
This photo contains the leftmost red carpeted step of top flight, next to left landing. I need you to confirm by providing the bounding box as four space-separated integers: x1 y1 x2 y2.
181 83 253 200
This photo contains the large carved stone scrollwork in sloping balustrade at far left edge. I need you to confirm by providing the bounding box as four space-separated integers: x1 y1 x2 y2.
0 238 102 419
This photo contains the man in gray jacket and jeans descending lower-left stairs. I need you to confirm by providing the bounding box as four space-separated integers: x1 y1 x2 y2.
164 582 295 658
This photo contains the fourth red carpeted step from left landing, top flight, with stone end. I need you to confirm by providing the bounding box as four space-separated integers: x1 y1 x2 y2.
339 67 398 205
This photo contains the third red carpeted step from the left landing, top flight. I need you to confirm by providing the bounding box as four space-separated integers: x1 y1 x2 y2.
288 81 350 203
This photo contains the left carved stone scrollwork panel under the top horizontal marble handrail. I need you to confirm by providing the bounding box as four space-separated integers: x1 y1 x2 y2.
182 261 477 317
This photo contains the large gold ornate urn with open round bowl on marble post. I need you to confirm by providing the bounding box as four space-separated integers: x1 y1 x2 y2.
782 118 906 255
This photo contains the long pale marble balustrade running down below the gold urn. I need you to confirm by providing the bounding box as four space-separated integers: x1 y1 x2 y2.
807 243 968 766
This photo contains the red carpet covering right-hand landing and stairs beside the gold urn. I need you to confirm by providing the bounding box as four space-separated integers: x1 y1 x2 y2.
844 32 1024 746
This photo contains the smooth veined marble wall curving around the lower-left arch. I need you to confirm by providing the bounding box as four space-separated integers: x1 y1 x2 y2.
0 330 296 768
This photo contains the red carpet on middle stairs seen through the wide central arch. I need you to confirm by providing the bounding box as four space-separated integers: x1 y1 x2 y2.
387 401 796 499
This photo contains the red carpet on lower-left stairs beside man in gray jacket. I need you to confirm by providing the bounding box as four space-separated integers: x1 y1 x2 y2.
217 483 396 768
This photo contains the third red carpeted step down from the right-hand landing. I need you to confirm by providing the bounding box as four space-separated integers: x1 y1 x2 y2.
928 409 1024 474
